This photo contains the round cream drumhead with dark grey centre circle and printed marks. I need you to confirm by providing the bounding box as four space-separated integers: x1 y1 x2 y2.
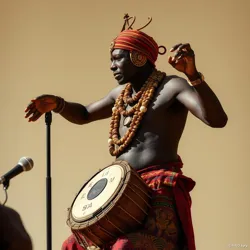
71 164 125 222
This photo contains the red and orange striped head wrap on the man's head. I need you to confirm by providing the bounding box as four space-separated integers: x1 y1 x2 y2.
113 30 159 65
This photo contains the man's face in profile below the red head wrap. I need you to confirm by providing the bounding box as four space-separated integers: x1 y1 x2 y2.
110 49 138 85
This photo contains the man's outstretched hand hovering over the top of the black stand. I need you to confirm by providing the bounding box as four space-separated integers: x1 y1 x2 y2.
24 95 57 122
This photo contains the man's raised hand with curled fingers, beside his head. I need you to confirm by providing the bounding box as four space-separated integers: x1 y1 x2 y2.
168 43 199 79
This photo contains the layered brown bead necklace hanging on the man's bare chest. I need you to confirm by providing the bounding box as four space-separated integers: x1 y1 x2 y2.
108 70 166 156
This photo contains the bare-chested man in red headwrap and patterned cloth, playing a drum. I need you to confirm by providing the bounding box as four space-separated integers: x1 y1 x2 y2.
26 15 227 250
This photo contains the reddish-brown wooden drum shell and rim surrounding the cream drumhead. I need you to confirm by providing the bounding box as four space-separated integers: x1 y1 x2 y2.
67 161 151 248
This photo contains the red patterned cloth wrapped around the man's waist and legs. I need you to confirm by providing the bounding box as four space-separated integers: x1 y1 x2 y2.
62 158 196 250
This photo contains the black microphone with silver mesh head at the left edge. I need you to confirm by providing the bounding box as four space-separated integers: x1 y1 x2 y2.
0 157 34 184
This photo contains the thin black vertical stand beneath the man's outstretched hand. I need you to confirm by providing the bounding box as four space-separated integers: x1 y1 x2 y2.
45 112 52 250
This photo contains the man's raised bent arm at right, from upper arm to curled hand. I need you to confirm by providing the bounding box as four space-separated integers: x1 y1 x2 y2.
168 43 228 128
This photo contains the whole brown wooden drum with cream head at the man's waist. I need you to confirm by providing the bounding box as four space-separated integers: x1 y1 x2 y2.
67 161 151 249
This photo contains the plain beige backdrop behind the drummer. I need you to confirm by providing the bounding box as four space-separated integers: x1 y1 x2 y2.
0 0 250 250
